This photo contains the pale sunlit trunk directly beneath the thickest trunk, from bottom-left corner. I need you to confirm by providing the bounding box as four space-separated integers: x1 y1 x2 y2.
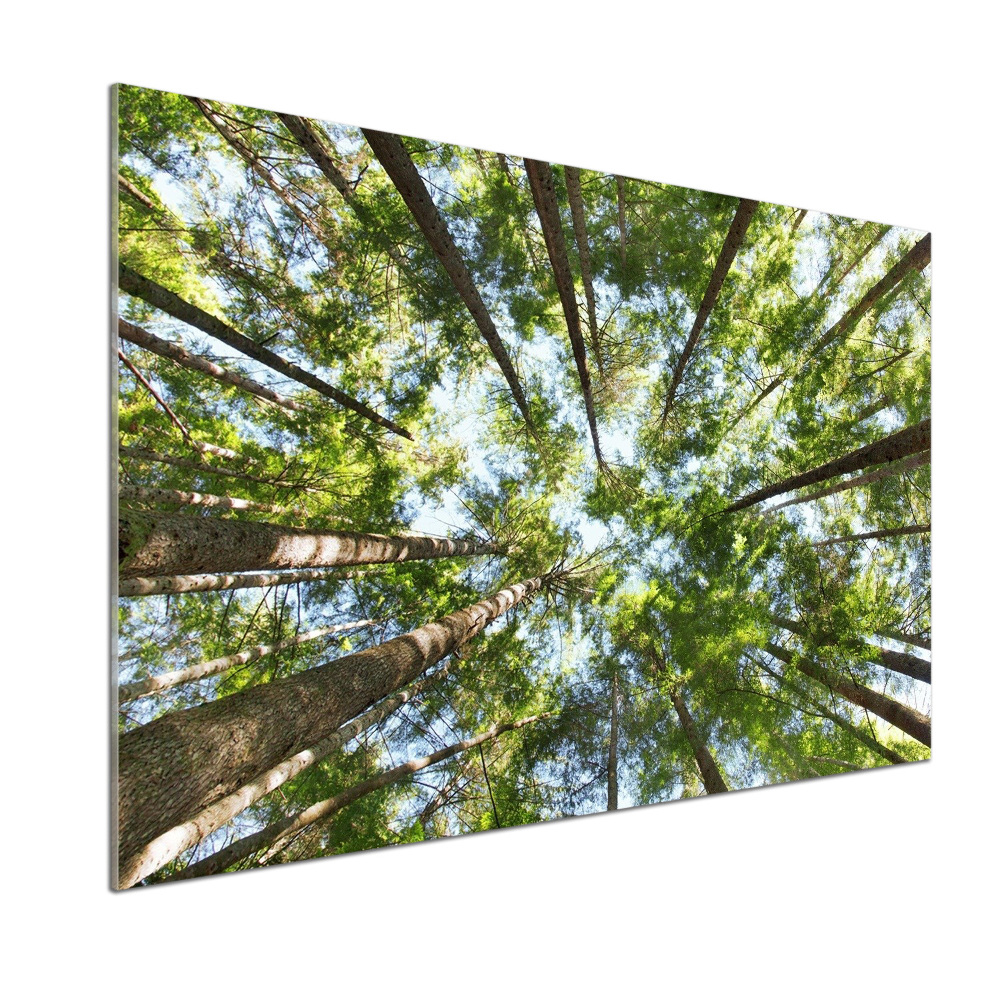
118 665 448 889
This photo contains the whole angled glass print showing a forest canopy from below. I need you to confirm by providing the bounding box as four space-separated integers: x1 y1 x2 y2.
111 84 943 889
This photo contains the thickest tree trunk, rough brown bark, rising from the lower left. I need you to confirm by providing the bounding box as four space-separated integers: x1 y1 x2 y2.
118 577 545 876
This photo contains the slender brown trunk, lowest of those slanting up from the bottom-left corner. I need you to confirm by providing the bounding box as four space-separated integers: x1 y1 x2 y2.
171 713 550 880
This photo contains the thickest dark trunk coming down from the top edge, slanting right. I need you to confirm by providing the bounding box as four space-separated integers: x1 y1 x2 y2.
362 129 534 433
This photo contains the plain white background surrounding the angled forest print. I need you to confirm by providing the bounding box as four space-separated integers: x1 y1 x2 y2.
0 0 1000 997
